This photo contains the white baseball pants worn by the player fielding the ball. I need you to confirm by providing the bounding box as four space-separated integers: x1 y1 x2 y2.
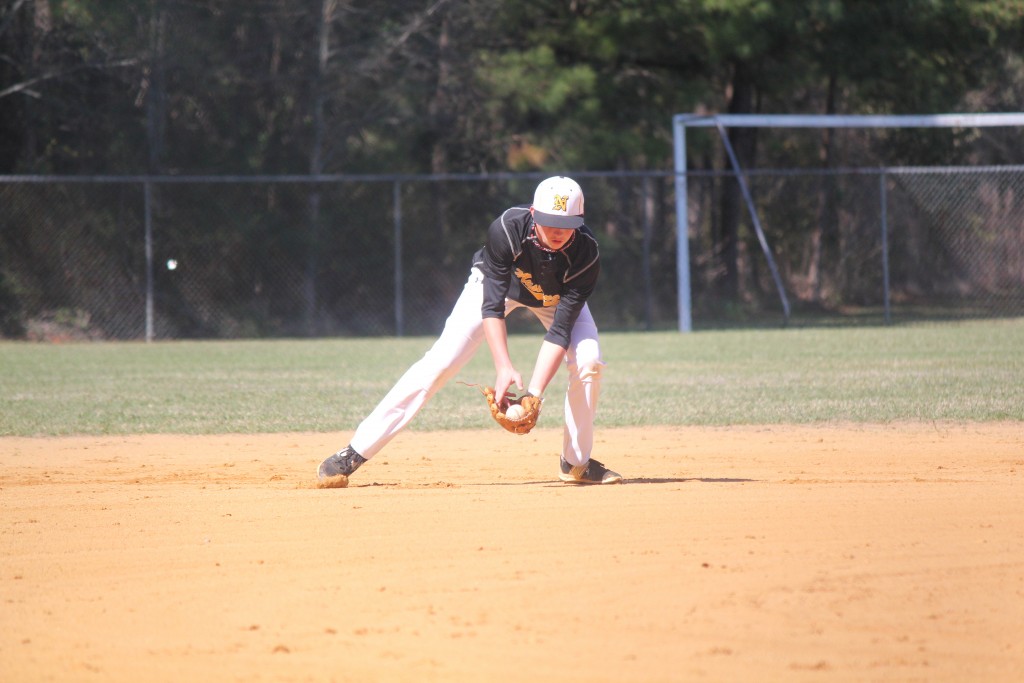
350 267 604 466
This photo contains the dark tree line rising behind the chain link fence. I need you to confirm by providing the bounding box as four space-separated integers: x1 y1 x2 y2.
0 0 1024 339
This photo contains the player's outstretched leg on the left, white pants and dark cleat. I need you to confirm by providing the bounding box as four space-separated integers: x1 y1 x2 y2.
318 268 483 478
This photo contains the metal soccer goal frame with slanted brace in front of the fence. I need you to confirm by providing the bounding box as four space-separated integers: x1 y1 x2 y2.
672 113 1024 332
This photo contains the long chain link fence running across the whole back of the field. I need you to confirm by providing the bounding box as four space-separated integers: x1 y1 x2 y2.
0 167 1024 340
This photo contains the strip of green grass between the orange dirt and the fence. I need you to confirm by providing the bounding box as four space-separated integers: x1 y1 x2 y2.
0 319 1024 436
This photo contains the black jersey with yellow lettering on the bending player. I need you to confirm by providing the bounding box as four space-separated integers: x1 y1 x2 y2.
473 207 601 348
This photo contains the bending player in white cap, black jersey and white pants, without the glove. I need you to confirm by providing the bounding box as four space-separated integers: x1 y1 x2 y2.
317 176 623 485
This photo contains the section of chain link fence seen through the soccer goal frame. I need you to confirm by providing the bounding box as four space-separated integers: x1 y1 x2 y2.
688 166 1024 323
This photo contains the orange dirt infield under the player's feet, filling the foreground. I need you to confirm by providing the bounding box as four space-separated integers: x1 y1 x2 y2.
0 424 1024 683
